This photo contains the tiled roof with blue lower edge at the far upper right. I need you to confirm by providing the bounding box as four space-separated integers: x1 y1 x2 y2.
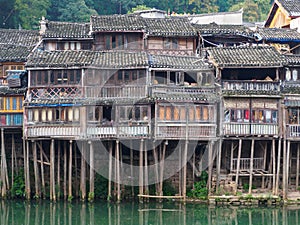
257 28 300 42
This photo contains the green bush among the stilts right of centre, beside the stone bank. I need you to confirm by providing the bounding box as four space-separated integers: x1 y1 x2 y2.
187 171 208 199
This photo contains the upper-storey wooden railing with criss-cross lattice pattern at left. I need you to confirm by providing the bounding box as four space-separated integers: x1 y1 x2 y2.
30 86 82 99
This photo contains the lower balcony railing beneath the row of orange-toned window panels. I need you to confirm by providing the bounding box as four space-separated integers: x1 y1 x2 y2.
155 124 216 140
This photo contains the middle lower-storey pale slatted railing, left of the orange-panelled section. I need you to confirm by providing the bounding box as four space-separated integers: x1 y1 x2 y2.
87 125 150 139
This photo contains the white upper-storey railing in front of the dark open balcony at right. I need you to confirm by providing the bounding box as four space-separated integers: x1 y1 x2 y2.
222 80 280 91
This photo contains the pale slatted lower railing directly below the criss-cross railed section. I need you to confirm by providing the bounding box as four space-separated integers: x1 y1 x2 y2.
25 125 80 138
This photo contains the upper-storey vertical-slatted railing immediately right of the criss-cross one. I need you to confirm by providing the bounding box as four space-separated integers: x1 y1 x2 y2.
85 84 147 98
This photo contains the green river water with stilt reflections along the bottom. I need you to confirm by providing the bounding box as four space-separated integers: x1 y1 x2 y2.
0 201 300 225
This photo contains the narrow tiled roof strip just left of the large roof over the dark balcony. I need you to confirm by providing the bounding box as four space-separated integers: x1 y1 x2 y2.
149 55 209 70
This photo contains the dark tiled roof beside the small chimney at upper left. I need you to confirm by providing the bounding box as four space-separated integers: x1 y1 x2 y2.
43 21 91 39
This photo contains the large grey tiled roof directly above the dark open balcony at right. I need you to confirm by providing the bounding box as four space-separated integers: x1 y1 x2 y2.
207 46 284 67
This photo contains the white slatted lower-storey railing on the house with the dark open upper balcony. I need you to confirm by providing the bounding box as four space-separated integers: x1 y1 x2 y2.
223 123 279 136
